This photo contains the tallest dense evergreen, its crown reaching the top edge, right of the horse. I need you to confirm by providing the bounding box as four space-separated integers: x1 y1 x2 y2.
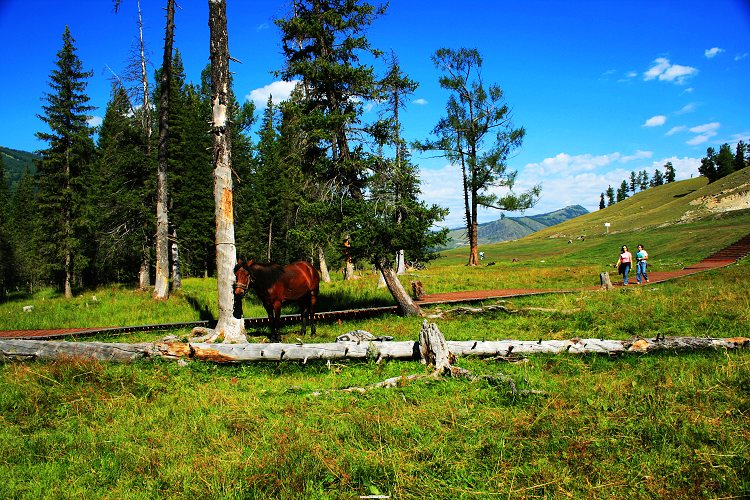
277 0 385 279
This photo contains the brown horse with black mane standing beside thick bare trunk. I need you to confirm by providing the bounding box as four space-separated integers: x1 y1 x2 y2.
234 259 320 342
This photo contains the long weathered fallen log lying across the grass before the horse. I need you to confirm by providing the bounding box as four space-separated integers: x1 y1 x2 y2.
0 337 750 363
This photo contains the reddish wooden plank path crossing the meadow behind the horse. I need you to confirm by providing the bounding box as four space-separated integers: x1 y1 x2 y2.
0 234 750 340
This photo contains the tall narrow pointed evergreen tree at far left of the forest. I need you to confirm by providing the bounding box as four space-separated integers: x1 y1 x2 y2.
36 26 94 297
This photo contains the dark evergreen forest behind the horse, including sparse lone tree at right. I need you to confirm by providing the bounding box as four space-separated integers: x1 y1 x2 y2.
0 0 539 295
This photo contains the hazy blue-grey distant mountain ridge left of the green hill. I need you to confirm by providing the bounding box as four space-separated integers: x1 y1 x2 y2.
445 205 589 249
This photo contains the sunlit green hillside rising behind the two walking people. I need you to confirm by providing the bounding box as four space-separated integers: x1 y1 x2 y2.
441 167 750 272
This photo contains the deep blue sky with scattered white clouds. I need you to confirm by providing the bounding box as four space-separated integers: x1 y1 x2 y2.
0 0 750 227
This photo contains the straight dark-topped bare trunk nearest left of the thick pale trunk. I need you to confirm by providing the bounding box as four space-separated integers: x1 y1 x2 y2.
154 0 175 300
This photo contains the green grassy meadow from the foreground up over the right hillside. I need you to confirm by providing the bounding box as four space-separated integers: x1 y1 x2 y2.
0 173 750 499
